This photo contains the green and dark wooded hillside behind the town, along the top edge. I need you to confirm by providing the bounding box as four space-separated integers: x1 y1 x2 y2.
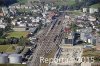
0 0 100 9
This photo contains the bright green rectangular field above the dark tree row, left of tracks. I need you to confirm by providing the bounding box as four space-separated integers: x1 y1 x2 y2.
7 31 28 38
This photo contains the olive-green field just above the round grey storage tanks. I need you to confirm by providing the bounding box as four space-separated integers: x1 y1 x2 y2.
0 45 17 52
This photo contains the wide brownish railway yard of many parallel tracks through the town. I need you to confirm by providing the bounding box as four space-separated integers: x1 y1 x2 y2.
28 15 62 66
